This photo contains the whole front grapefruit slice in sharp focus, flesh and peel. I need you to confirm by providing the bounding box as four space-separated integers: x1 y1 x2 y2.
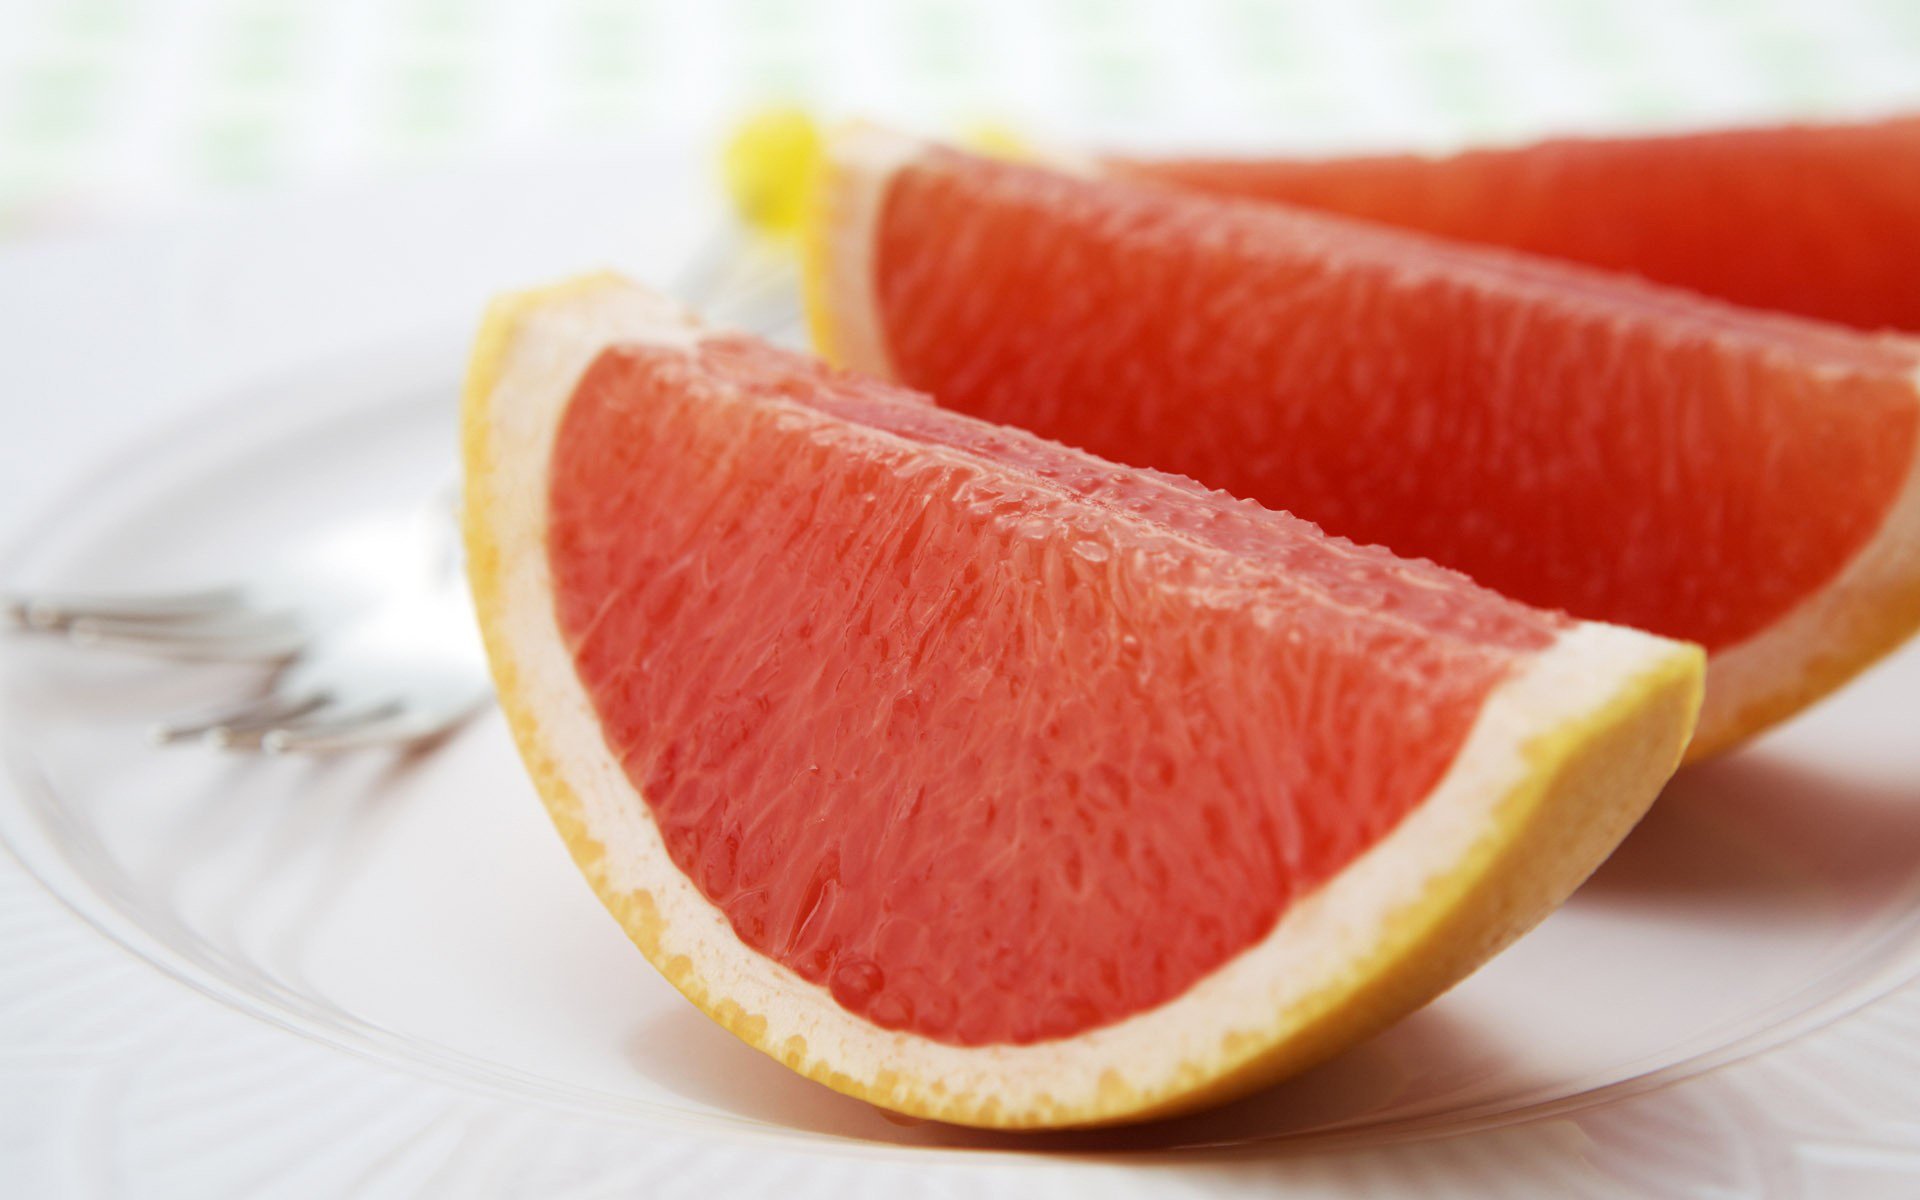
465 278 1701 1127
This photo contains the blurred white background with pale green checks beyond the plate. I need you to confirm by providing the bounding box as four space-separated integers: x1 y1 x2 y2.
11 0 1920 238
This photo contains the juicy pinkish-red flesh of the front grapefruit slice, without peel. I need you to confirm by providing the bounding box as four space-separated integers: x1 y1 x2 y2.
549 338 1569 1044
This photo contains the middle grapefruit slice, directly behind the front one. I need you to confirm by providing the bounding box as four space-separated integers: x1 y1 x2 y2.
808 129 1920 756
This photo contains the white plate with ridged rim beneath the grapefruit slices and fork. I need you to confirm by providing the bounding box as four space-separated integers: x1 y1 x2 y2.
0 146 1920 1200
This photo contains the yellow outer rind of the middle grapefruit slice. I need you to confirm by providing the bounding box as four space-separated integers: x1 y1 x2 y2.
801 138 1920 762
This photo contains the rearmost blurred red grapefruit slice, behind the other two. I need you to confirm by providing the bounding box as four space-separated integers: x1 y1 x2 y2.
1110 117 1920 330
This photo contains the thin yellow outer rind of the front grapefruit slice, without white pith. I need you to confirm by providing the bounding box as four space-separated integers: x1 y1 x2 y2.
461 276 1701 1129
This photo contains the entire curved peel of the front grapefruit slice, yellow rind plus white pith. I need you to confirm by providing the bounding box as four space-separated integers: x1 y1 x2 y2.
463 276 1701 1129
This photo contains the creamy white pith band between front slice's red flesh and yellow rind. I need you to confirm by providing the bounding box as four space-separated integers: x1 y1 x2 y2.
468 282 1684 1112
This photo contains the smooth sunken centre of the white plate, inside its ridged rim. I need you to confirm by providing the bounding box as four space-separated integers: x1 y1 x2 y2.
0 318 1920 1154
